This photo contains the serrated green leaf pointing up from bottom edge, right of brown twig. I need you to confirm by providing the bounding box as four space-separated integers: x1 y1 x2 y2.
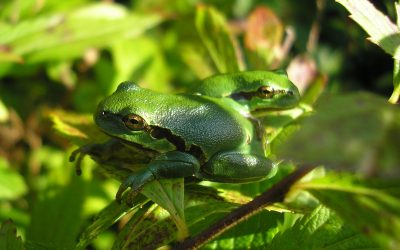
265 206 379 249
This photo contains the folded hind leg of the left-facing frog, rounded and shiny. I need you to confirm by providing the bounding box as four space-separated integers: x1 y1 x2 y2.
197 151 276 183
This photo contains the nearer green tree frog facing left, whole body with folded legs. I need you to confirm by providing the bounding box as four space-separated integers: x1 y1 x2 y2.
94 82 275 201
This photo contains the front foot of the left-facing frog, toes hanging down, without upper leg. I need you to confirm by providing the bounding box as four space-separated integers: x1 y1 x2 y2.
115 170 156 207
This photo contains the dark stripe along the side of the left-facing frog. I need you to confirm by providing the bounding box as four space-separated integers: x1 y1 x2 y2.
149 125 206 163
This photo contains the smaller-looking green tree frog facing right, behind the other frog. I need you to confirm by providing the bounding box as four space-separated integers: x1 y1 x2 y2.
194 71 300 117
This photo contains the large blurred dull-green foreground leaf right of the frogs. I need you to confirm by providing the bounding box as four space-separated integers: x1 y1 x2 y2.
277 92 400 177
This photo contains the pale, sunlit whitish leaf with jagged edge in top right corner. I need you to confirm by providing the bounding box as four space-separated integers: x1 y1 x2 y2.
336 0 400 60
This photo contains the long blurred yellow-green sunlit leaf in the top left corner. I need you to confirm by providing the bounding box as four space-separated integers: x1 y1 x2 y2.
0 3 162 63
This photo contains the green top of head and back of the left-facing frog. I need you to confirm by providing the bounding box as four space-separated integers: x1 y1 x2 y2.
100 82 254 156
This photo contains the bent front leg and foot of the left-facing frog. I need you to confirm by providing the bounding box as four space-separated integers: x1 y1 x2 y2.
116 151 200 204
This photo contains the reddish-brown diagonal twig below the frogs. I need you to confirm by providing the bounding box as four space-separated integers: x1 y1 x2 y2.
172 167 314 250
